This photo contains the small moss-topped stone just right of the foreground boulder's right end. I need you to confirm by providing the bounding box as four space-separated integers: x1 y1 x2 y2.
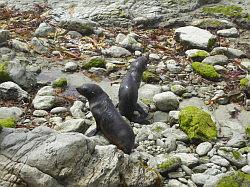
157 157 181 172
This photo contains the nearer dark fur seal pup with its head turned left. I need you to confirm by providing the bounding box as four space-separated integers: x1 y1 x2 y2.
76 84 135 154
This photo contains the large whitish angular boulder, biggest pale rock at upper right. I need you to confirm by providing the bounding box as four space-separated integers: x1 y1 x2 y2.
175 26 216 49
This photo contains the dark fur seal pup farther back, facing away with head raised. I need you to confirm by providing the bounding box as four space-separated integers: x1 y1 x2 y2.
118 56 149 124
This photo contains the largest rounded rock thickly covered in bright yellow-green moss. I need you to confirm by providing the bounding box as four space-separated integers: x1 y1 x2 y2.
179 106 217 141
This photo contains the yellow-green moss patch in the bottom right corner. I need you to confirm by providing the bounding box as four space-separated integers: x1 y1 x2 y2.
216 171 250 187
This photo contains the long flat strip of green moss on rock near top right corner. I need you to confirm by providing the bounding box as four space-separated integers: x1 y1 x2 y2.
202 5 243 17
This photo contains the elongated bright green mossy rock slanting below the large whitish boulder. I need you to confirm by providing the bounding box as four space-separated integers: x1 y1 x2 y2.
192 62 220 80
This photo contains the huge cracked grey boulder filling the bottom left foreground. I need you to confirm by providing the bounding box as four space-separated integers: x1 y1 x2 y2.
0 127 161 187
